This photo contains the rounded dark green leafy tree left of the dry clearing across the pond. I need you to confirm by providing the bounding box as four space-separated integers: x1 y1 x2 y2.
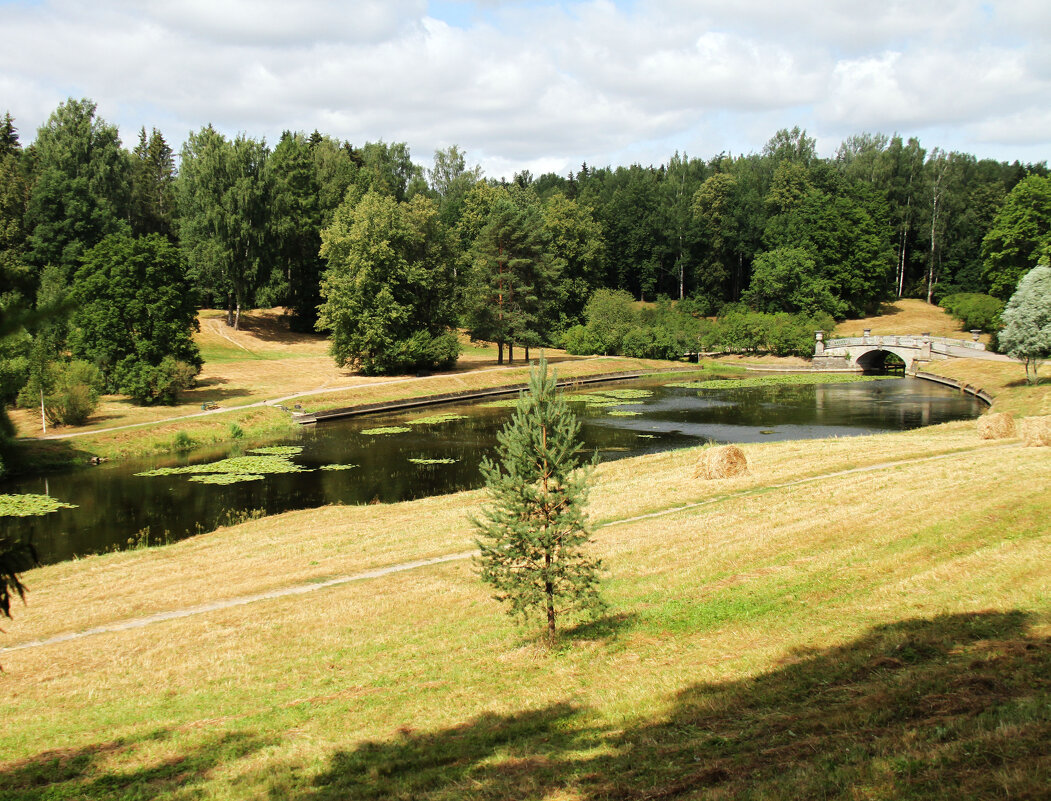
69 233 202 403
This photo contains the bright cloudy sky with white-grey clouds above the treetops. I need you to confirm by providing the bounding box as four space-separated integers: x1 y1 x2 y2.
0 0 1051 178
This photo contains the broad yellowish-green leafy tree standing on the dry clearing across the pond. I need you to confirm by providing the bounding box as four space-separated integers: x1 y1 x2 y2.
317 191 458 373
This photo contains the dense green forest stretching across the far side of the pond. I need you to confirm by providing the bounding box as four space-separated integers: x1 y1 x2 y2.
0 99 1051 418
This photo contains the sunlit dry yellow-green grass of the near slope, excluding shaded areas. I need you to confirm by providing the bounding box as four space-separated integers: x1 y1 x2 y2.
0 420 1051 798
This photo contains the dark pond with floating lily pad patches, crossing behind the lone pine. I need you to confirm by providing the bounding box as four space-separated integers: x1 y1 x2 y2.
0 377 983 563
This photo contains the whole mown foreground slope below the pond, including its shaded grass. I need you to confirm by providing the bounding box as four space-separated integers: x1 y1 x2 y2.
0 407 1051 799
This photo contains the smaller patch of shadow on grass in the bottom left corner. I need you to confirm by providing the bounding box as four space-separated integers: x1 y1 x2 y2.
0 730 272 801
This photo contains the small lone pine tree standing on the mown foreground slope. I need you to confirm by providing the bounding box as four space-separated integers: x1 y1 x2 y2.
474 356 604 640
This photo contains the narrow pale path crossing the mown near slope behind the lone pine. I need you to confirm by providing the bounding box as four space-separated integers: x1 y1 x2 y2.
0 443 1022 654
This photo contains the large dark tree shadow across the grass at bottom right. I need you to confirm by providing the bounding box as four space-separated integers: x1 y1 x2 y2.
283 612 1051 801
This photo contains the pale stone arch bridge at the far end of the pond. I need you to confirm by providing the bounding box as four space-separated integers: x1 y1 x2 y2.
813 331 1010 372
